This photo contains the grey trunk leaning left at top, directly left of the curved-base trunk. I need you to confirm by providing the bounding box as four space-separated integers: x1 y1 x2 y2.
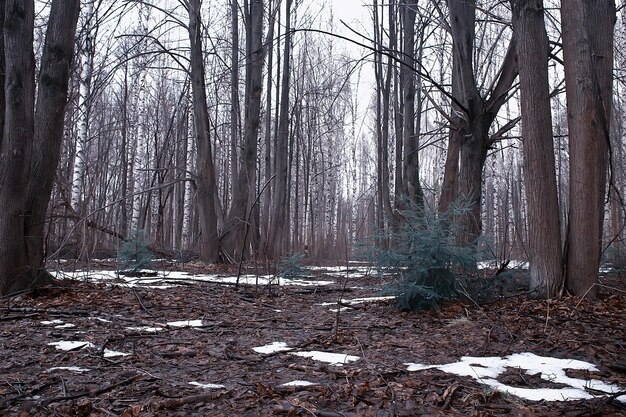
189 0 219 262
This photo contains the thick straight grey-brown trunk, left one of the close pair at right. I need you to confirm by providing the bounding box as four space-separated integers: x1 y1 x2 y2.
511 0 563 299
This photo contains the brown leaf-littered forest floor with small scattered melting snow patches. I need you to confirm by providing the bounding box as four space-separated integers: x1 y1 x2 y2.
0 265 626 417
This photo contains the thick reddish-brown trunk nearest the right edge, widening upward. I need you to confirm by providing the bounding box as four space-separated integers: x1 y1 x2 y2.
561 0 616 297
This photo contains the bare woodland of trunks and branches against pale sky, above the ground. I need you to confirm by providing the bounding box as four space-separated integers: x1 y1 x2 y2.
0 0 626 297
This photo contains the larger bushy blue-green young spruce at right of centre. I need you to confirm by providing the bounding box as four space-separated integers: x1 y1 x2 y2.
375 202 476 310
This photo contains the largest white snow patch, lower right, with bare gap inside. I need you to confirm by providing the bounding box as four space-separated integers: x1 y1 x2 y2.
405 353 626 403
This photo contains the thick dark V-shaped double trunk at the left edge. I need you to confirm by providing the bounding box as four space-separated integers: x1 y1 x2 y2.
0 0 79 295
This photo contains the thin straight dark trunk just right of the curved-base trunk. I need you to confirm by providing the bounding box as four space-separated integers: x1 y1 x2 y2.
268 0 293 258
